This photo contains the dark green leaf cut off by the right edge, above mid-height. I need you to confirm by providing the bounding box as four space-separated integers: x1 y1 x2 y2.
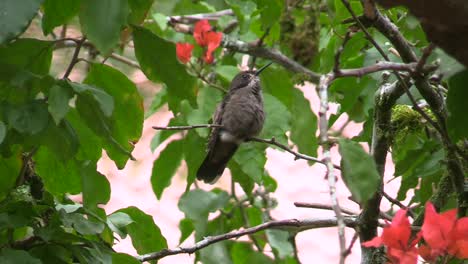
447 70 468 141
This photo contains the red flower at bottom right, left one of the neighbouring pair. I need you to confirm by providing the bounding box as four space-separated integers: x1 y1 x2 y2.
362 210 420 264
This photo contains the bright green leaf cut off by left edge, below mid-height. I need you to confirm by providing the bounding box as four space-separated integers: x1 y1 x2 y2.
0 148 23 201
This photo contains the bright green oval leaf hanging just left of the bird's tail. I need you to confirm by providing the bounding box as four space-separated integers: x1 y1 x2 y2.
151 140 183 199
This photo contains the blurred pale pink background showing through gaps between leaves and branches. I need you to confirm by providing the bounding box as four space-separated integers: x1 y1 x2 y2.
98 71 400 264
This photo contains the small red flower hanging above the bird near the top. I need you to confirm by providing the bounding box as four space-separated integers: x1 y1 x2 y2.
193 19 223 64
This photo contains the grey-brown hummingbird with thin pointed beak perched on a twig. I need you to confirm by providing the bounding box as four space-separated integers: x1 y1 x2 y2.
197 62 273 184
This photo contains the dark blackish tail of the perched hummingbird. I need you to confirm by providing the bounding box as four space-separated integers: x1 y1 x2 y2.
197 140 239 184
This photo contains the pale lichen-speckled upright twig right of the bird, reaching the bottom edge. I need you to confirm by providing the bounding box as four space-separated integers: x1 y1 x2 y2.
318 74 346 264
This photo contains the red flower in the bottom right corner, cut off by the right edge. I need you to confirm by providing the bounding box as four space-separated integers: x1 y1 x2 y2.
420 202 468 260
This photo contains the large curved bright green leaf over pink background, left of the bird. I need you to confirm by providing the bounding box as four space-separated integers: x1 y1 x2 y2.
84 64 144 169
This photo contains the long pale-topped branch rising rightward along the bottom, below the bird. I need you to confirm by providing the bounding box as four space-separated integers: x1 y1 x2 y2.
137 217 356 262
